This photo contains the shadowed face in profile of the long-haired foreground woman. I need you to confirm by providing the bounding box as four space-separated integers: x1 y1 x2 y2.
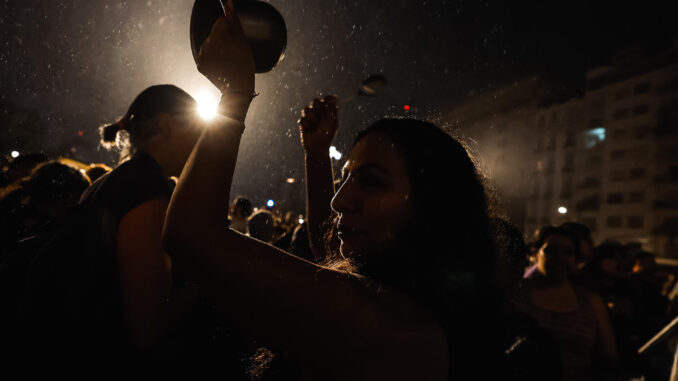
332 133 414 257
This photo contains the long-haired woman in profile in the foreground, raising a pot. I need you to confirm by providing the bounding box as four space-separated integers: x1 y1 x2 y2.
164 5 502 380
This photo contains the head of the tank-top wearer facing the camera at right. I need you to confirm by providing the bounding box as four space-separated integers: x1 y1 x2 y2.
536 226 579 283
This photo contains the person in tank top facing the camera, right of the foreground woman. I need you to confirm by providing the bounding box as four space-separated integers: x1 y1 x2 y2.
520 226 618 381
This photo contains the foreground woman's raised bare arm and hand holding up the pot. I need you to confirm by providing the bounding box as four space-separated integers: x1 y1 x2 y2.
164 1 447 380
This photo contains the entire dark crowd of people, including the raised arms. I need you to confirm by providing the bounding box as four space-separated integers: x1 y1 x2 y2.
0 2 678 381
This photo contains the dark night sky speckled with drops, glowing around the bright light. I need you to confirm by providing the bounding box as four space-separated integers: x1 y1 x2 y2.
0 0 676 211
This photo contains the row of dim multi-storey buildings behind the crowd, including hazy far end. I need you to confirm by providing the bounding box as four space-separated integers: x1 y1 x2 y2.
446 40 678 257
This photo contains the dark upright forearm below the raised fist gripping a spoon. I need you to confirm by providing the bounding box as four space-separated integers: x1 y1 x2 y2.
305 152 334 263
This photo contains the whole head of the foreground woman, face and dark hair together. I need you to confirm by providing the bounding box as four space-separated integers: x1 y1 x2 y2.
332 119 494 302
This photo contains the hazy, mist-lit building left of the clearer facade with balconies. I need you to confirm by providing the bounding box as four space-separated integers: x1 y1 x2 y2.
446 76 559 227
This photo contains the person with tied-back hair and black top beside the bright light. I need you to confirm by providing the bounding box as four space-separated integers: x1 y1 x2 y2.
80 85 203 357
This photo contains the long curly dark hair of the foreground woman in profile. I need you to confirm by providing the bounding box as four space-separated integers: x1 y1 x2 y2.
326 119 508 375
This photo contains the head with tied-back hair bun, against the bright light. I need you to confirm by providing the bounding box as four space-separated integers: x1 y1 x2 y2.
101 85 203 176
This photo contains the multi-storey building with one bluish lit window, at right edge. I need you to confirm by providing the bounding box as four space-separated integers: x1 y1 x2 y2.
524 42 678 257
